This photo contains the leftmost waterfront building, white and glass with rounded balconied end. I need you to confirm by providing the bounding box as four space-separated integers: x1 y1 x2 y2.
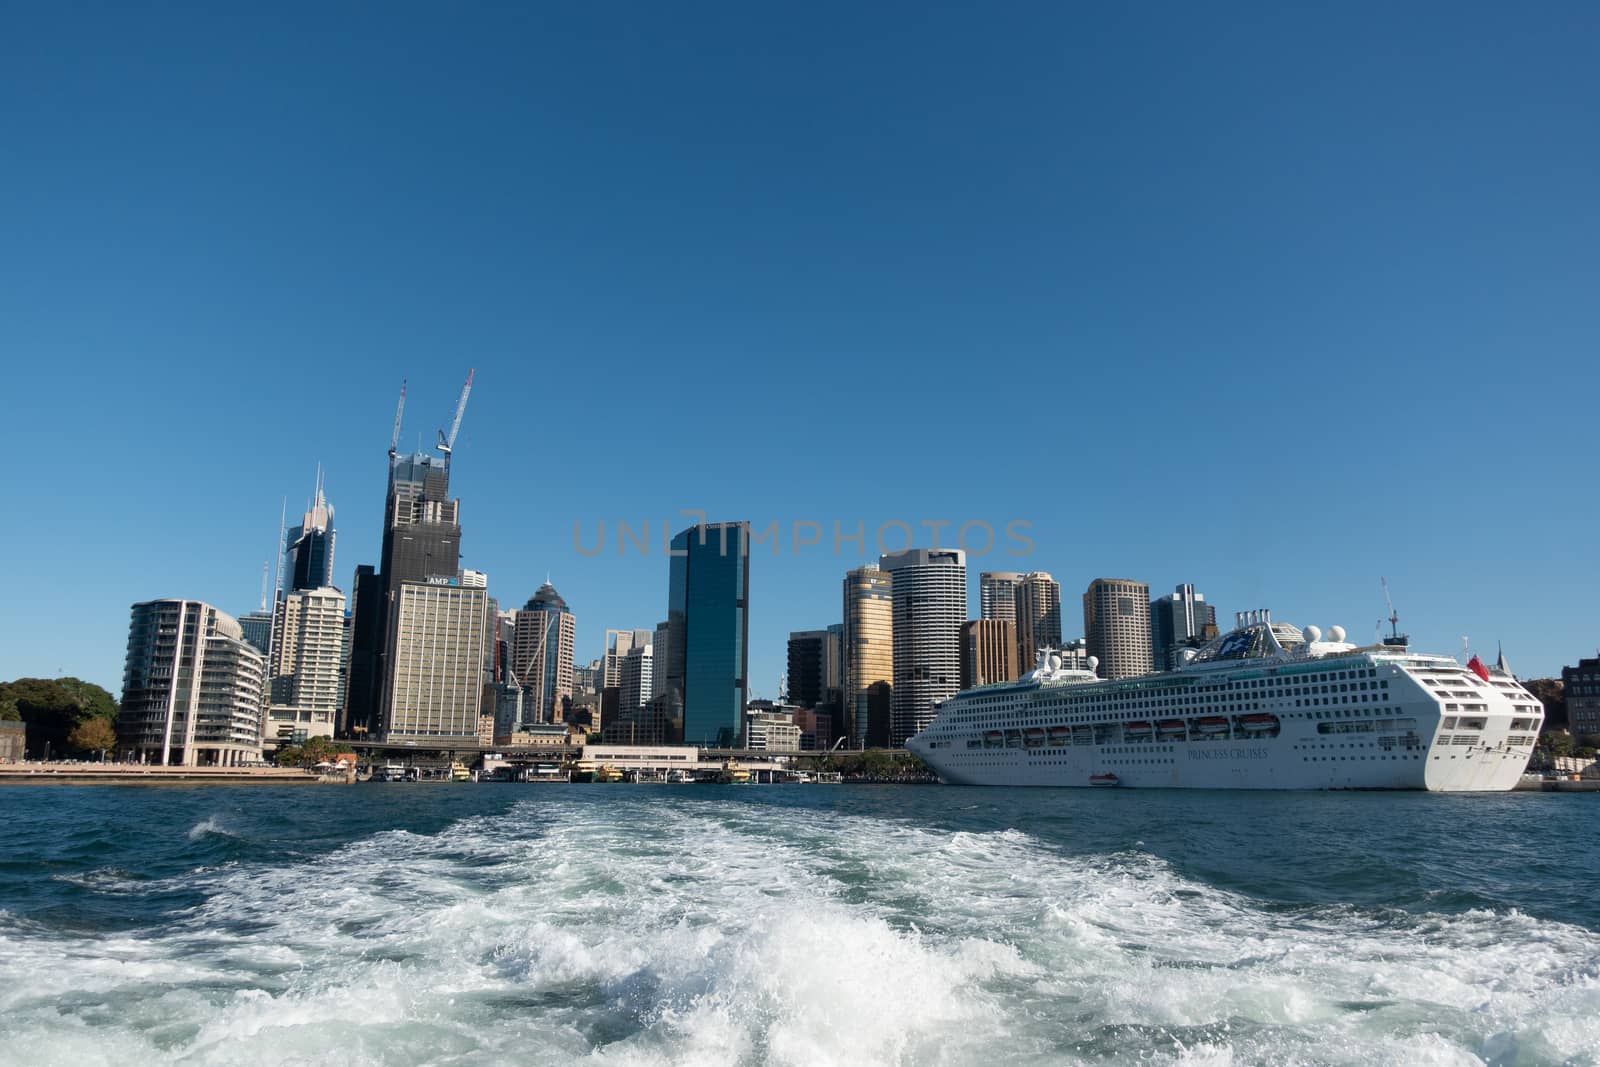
117 600 267 766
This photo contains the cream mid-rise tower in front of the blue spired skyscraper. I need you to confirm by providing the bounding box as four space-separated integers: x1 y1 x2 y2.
262 587 344 747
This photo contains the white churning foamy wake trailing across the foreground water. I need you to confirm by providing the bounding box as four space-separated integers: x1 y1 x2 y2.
0 793 1600 1064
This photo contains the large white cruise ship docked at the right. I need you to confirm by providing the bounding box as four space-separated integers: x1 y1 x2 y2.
906 611 1544 792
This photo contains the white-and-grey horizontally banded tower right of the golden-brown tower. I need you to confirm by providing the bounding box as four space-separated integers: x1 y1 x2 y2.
878 549 966 749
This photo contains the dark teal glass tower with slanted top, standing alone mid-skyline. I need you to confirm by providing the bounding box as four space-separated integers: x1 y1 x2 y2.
656 523 750 749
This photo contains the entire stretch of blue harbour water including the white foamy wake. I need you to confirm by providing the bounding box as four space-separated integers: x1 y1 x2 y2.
0 785 1600 1065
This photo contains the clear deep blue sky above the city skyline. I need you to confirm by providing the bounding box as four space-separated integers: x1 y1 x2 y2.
0 3 1600 696
